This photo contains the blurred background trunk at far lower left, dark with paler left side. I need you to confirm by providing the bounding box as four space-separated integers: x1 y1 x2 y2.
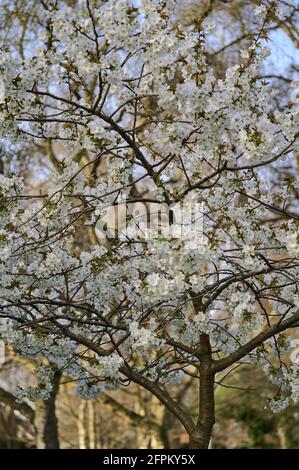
35 371 62 449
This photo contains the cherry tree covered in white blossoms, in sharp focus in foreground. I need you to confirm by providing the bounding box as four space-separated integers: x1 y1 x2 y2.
0 0 299 448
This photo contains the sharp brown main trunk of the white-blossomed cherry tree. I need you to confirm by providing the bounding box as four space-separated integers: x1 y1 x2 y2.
190 334 215 449
